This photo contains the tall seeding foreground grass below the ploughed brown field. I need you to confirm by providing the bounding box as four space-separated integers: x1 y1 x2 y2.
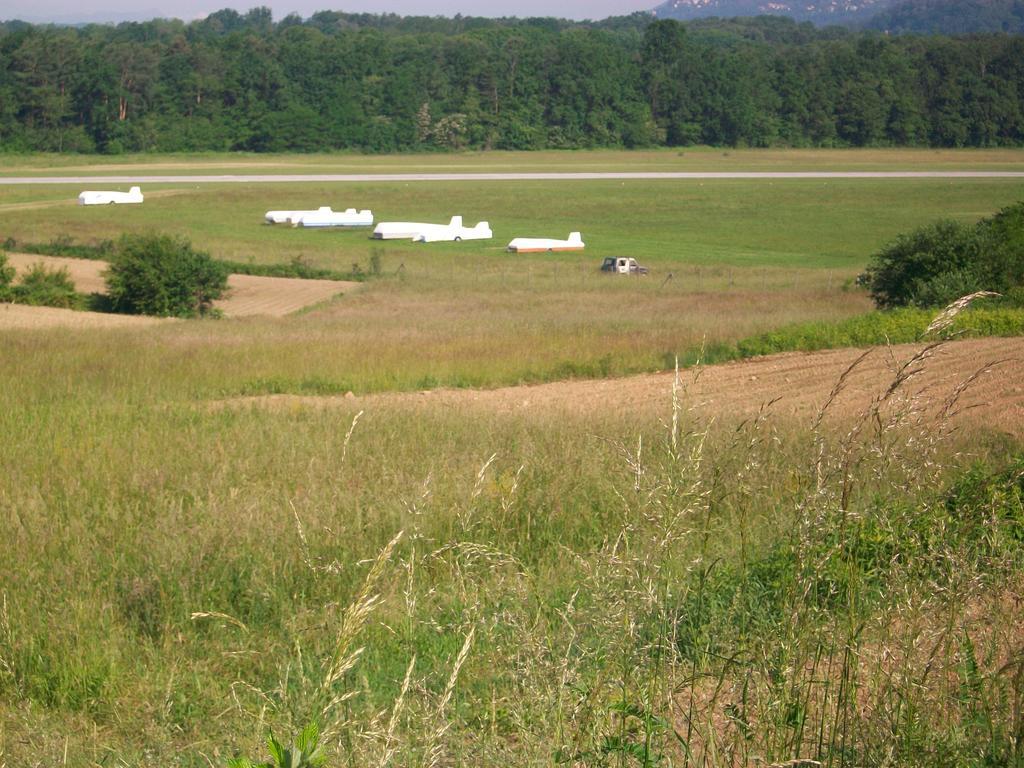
0 321 1024 766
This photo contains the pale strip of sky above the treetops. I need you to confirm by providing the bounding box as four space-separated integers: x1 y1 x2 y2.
0 0 660 23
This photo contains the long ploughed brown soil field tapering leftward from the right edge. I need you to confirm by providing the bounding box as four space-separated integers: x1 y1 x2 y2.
231 338 1024 436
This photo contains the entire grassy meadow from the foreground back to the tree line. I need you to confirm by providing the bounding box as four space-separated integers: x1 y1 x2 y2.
0 151 1024 768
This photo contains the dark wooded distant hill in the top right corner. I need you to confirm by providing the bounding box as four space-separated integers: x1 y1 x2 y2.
867 0 1024 35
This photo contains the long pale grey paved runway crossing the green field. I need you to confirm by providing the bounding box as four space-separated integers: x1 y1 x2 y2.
0 170 1024 185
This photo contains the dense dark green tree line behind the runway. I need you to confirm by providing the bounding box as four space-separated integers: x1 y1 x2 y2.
0 8 1024 153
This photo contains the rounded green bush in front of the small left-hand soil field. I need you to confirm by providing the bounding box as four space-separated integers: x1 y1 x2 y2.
104 234 228 317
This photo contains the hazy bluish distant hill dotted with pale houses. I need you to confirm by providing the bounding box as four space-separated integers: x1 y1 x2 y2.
652 0 893 25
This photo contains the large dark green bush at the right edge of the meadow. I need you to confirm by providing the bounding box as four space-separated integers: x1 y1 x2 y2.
864 203 1024 308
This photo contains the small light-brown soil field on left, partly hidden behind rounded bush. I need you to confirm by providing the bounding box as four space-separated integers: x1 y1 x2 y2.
7 253 359 317
